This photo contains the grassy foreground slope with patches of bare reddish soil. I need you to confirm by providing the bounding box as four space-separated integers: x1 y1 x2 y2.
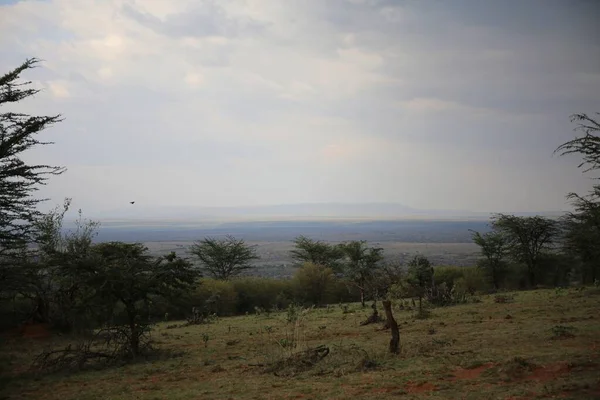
0 288 600 400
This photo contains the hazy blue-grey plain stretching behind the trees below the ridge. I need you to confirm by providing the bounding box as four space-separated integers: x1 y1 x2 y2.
91 218 489 277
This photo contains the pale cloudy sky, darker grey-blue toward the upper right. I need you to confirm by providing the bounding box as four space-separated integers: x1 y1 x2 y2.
0 0 600 214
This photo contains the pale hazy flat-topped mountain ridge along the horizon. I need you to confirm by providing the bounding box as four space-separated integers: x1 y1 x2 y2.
90 202 563 221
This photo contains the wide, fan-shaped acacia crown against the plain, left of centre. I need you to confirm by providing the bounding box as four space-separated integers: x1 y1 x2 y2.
190 235 260 280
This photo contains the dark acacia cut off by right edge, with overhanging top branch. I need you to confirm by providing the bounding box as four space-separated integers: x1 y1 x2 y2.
554 113 600 283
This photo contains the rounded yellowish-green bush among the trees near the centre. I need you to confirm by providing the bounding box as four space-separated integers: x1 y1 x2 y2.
293 263 335 306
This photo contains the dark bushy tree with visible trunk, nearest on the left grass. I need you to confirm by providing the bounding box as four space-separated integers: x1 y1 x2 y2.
86 242 199 357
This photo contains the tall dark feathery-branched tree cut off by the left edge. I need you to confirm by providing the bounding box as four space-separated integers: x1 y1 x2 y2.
0 58 64 260
